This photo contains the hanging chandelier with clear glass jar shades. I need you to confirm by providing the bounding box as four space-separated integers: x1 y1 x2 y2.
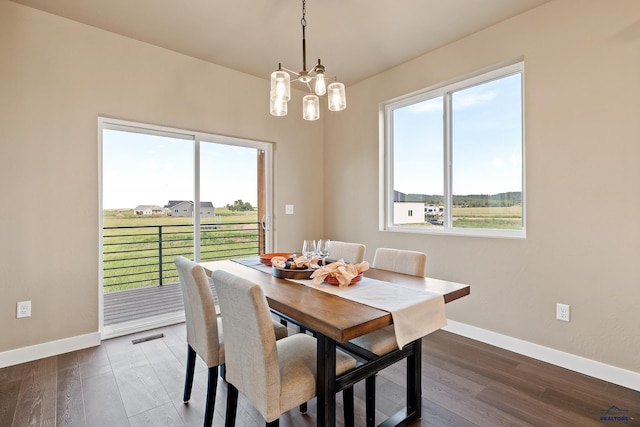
270 0 347 120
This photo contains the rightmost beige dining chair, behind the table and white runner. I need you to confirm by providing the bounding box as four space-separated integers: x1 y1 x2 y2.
349 248 427 426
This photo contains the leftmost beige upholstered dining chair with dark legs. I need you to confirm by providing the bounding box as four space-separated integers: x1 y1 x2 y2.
174 256 288 427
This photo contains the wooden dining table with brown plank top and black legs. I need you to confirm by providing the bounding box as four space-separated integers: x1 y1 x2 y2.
200 257 470 427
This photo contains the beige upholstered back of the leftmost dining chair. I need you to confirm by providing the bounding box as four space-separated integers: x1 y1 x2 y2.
174 256 224 367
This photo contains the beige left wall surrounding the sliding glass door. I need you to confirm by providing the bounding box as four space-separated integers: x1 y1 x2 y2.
0 0 323 352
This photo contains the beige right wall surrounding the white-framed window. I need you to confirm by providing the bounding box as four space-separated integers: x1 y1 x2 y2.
325 0 640 372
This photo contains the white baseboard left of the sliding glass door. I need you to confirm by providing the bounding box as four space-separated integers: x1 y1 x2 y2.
0 332 100 368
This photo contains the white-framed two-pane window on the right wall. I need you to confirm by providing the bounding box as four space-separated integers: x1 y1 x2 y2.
381 63 525 237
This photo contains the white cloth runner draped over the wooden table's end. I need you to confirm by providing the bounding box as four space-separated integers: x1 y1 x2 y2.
288 277 447 348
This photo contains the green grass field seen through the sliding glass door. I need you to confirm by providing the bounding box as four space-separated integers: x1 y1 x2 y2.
103 209 259 292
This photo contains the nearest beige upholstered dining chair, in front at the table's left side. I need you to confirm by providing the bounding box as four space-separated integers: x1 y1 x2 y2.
212 270 356 427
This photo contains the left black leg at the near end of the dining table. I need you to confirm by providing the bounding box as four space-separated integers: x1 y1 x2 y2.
316 333 336 427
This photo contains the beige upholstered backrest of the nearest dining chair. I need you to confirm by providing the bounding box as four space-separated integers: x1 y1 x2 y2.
212 270 281 420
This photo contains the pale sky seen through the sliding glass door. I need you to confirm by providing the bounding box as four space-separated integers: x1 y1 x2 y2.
102 129 257 209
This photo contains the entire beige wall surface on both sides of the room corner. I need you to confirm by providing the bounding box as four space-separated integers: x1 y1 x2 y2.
0 0 640 378
